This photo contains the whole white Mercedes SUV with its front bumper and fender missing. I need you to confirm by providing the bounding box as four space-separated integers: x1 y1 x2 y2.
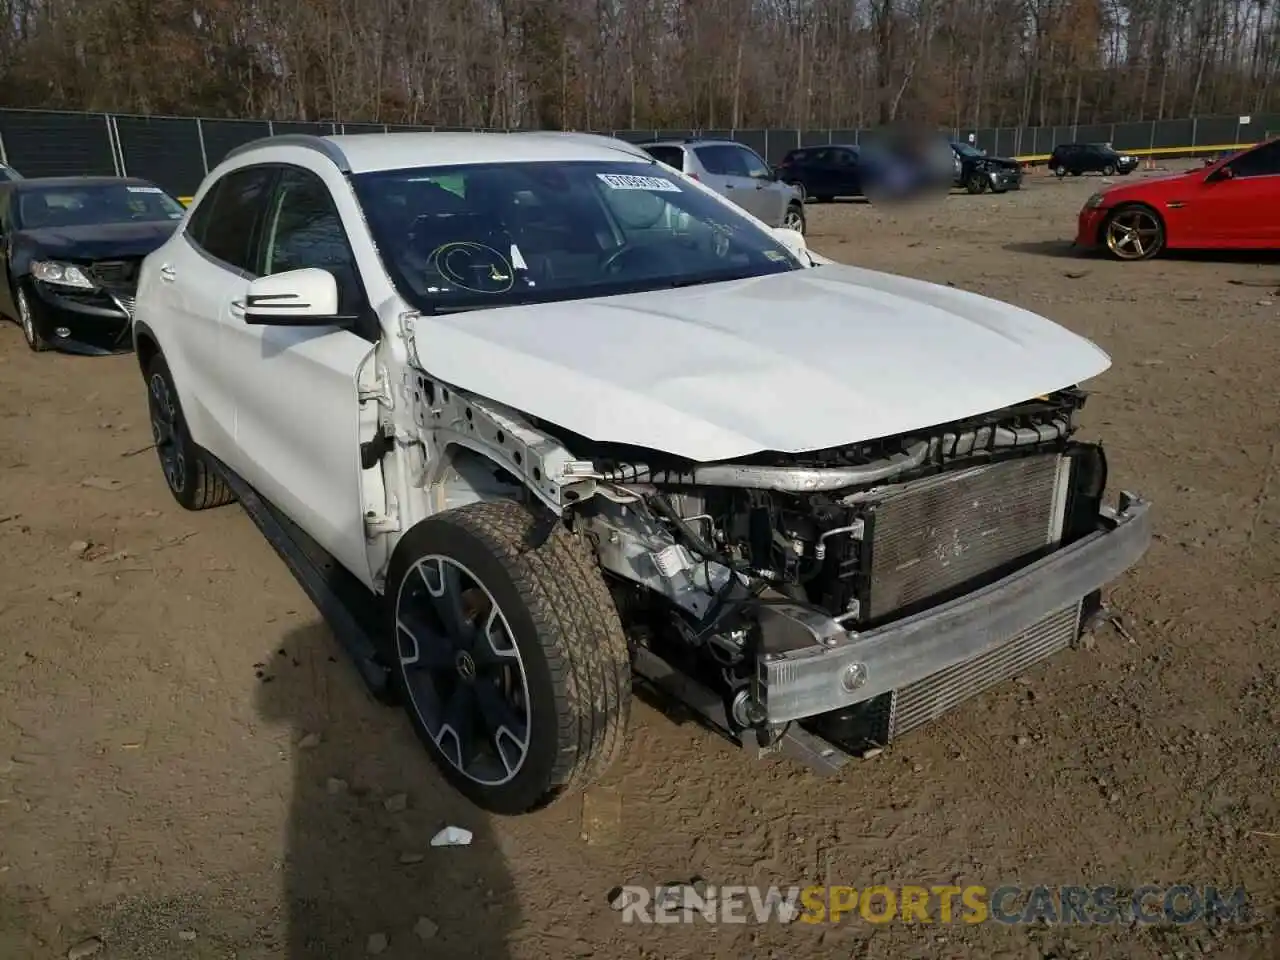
134 133 1151 813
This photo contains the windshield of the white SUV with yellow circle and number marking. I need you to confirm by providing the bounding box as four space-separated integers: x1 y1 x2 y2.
352 161 803 312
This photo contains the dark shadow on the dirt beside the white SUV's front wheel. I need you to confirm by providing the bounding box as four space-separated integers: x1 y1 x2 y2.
257 623 520 960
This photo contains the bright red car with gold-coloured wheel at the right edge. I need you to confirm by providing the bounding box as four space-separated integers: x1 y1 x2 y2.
1075 138 1280 260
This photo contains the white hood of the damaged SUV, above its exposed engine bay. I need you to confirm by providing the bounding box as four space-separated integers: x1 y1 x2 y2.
412 264 1111 462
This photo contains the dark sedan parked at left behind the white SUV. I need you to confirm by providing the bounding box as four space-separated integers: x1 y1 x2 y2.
0 177 186 355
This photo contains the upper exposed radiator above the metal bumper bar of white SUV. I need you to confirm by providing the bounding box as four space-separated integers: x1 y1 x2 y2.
863 453 1070 620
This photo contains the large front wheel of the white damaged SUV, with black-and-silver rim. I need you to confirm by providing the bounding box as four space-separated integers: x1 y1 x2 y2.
385 502 631 815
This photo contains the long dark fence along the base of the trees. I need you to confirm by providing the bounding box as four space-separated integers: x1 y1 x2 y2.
0 110 1280 197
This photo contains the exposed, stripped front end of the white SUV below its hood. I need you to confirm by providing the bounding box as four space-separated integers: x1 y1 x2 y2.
404 375 1151 769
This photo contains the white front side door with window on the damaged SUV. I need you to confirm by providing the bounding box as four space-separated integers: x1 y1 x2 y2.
220 165 378 584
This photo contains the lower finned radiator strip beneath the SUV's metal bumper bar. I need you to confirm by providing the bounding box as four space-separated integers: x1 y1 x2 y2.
884 603 1080 742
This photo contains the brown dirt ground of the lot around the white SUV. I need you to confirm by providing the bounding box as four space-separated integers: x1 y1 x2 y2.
0 165 1280 960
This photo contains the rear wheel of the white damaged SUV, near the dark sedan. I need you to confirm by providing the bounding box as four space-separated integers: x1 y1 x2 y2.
147 353 236 511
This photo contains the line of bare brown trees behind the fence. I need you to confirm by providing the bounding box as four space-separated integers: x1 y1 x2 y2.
0 0 1280 129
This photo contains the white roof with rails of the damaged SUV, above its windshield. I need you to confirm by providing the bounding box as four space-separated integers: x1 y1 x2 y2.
228 131 653 173
